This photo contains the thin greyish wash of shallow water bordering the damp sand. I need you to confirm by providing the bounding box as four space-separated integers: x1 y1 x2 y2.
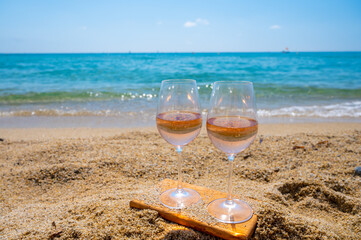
0 113 361 129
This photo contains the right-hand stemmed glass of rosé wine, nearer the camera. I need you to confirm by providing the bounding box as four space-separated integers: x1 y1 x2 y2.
207 81 258 223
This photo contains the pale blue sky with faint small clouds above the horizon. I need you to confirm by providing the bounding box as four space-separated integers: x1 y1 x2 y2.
0 0 361 53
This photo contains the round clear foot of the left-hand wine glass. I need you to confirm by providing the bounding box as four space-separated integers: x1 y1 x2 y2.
159 188 201 209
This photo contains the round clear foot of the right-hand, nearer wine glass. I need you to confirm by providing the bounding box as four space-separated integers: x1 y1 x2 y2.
207 198 253 223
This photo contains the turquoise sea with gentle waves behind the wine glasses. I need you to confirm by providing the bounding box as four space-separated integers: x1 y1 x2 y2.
0 52 361 128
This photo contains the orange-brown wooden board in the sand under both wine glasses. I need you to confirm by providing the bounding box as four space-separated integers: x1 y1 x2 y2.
130 179 257 240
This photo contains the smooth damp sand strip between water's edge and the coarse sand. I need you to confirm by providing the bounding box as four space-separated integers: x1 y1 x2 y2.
0 122 361 141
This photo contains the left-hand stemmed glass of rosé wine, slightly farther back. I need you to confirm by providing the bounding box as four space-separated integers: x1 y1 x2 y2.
156 79 202 209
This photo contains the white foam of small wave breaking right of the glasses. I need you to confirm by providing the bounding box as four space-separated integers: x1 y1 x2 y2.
258 101 361 118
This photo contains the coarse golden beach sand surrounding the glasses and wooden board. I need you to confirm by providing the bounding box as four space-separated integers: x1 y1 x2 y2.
0 123 361 239
